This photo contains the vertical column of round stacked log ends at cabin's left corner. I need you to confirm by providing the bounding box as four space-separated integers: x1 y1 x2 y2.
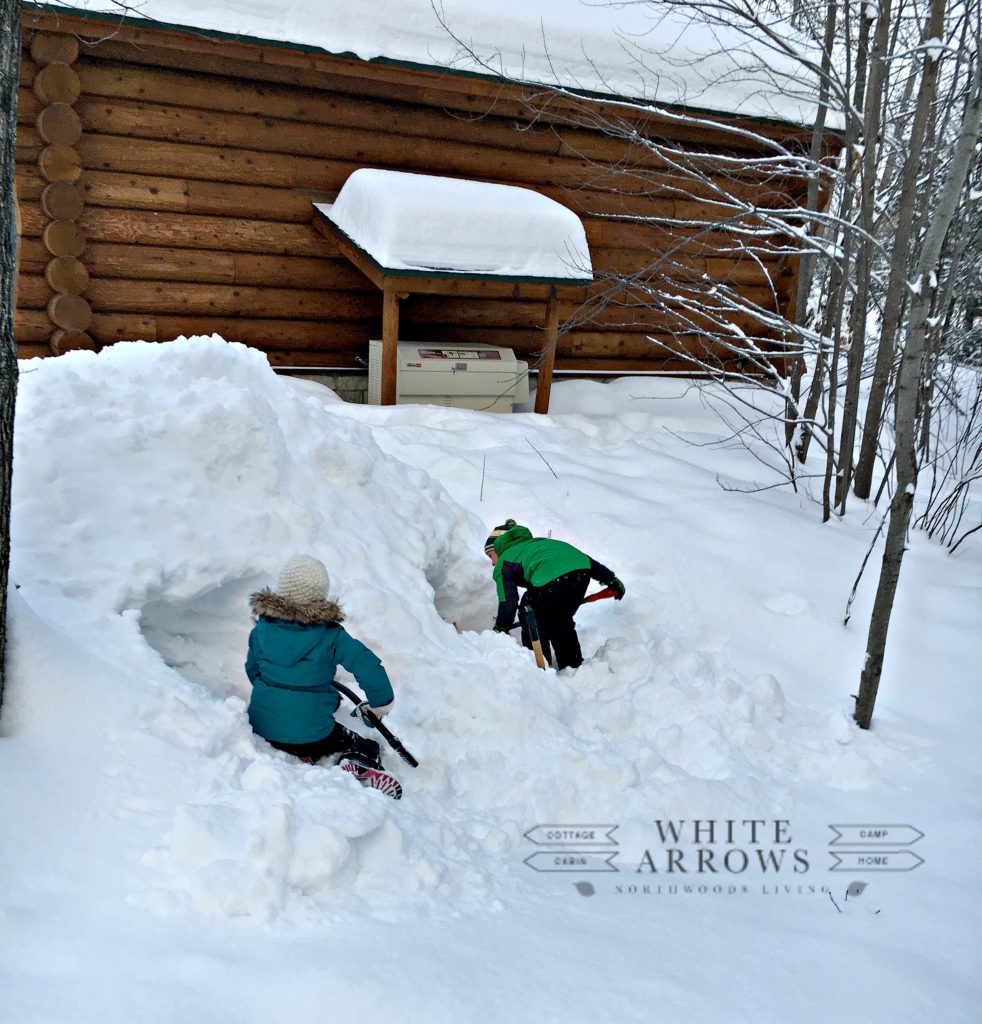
31 33 98 355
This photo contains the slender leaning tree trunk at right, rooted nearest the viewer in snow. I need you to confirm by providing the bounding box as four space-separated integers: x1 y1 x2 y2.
855 50 982 729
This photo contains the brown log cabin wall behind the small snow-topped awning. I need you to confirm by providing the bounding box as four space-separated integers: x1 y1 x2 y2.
15 13 805 372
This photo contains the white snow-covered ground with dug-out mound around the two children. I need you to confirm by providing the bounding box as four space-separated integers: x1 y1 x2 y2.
0 339 982 1024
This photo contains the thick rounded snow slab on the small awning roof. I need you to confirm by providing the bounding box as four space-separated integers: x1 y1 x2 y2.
315 168 593 284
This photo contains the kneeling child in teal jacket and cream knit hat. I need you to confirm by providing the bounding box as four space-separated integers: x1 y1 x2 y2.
246 555 394 768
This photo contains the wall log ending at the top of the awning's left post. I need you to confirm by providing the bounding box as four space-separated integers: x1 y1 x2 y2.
86 276 382 322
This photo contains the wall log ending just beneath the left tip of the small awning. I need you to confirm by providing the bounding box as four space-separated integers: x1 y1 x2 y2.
79 207 335 256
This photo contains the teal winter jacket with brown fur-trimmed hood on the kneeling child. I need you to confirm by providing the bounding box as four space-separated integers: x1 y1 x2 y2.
246 590 392 743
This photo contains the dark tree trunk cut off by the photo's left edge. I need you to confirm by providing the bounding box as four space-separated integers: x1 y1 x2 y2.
0 0 20 705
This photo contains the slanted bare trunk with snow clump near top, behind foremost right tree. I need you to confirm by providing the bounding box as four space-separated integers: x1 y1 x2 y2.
854 0 945 498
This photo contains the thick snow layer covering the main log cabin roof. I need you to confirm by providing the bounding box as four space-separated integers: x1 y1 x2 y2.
49 0 817 124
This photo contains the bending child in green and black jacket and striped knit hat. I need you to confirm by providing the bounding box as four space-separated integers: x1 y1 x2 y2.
484 519 625 670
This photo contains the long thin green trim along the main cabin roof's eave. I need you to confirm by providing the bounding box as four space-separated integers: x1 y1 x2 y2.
22 0 823 134
